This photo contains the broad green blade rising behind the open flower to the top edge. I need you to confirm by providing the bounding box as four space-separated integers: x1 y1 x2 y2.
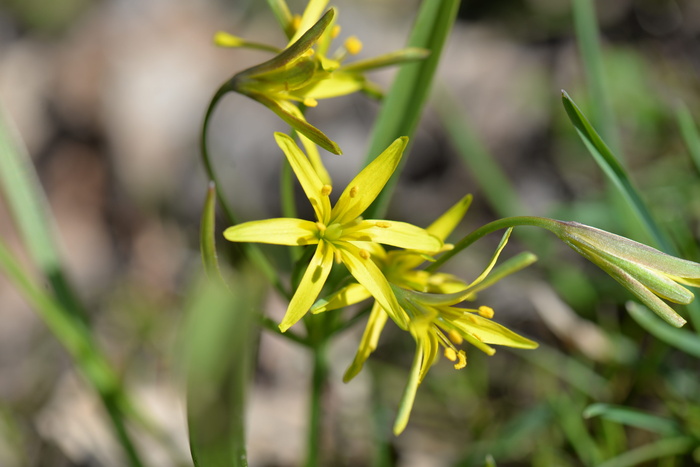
365 0 460 219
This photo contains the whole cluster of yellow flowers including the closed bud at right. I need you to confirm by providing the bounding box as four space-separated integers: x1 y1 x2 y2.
212 0 700 434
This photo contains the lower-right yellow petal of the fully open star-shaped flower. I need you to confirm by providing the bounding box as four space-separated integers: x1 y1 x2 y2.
336 242 407 329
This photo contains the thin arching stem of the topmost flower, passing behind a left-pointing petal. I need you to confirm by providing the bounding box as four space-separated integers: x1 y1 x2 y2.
199 81 292 299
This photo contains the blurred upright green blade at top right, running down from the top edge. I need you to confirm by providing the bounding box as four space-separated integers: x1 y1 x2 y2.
572 0 621 154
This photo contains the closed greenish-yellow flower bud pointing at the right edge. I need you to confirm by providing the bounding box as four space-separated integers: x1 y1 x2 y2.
543 219 700 327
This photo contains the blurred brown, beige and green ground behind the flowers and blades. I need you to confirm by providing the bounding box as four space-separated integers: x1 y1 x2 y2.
0 0 700 467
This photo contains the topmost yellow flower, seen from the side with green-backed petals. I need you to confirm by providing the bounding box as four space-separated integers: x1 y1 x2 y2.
215 0 428 154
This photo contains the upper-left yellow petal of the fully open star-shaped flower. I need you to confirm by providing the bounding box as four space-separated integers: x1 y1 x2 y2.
275 133 331 224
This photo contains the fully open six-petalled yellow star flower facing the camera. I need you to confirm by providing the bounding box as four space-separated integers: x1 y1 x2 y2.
224 133 442 331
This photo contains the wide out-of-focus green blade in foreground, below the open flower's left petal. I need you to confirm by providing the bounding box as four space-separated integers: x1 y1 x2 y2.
182 271 262 467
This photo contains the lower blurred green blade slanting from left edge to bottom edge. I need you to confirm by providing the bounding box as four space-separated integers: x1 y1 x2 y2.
0 241 143 467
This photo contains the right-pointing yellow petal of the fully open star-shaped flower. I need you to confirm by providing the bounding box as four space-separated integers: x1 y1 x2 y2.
352 220 442 251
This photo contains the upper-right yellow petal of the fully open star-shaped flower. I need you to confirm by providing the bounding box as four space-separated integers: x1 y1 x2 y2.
331 136 408 224
